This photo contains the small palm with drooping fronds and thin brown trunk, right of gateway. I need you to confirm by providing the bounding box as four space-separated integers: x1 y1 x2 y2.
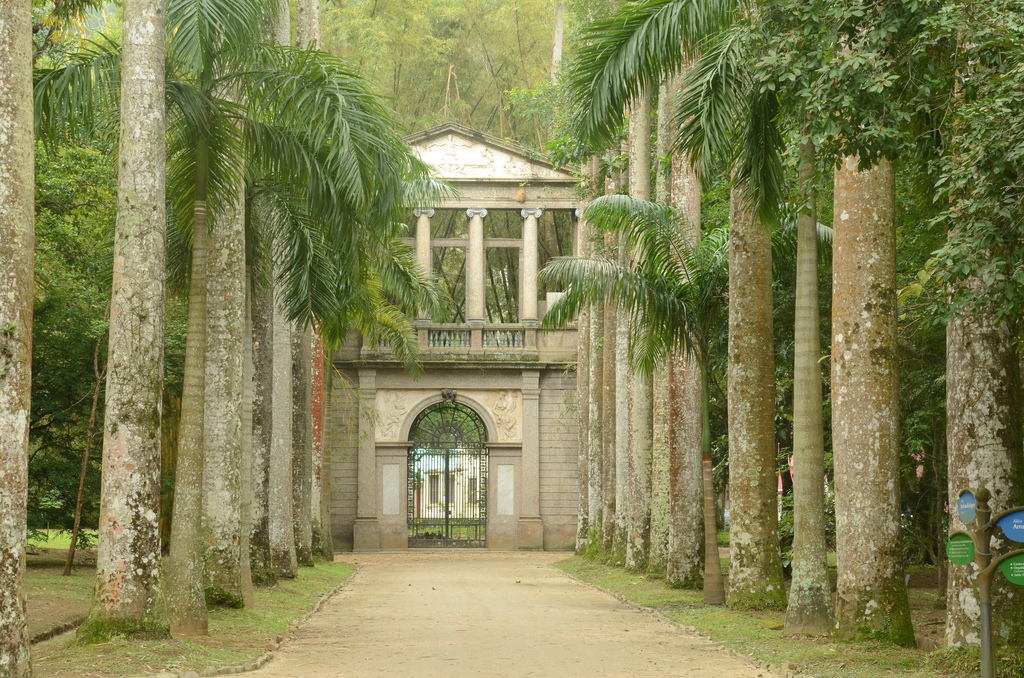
541 196 728 604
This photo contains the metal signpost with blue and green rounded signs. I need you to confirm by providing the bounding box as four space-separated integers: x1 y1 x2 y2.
946 488 1024 678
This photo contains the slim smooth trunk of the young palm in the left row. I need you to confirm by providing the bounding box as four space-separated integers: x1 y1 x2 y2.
165 161 209 635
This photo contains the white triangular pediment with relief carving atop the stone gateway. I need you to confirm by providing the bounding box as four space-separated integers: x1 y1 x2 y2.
407 123 575 182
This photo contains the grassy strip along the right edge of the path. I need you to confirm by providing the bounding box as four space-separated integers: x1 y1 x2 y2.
555 556 1024 678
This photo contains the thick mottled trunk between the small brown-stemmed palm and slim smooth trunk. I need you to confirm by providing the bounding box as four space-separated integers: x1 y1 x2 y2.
728 186 785 609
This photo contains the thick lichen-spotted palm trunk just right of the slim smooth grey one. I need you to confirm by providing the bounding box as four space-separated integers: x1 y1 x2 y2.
831 157 914 645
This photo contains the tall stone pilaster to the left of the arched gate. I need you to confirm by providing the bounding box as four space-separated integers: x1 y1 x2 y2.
352 370 380 551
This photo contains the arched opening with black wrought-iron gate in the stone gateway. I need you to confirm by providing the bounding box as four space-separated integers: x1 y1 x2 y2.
408 401 487 548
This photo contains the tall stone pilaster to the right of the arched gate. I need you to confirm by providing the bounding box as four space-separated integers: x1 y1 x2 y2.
517 370 544 550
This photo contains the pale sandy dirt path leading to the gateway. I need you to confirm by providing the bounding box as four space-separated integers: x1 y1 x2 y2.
250 551 773 678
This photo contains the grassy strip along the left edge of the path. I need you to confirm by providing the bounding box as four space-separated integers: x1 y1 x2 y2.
32 562 355 678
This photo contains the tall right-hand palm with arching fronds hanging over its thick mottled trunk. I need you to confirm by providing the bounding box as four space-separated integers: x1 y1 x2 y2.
569 0 785 608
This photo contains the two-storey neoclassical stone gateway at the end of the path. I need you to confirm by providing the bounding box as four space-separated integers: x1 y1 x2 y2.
325 124 579 551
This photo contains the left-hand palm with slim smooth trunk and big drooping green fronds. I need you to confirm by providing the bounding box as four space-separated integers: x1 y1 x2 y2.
37 0 442 633
